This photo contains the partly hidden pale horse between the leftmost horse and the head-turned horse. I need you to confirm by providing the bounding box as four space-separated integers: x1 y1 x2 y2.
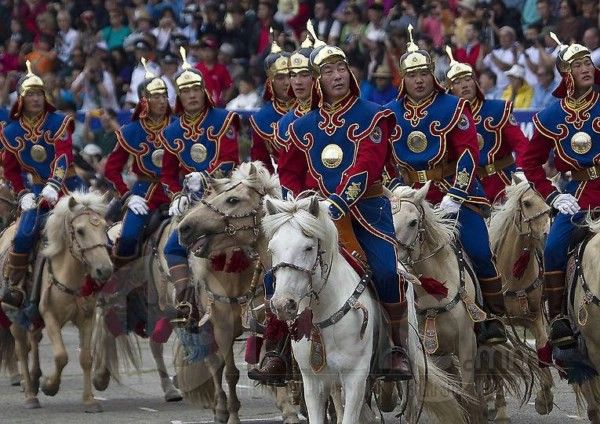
93 220 182 402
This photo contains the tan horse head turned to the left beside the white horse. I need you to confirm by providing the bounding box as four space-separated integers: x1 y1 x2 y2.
177 162 280 257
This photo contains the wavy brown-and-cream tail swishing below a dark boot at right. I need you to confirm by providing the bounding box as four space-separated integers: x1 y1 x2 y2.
475 334 543 406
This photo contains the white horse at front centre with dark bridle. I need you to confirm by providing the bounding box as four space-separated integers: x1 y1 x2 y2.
262 198 464 424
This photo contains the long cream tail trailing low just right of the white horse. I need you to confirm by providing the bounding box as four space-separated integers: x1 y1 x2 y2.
402 284 475 423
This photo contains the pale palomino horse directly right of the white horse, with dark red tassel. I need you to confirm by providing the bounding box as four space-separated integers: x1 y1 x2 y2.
388 183 540 422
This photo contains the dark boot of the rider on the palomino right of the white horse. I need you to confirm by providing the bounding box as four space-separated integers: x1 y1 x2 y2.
477 276 507 345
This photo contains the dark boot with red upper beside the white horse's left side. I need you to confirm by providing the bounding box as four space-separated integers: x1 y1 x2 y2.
248 311 289 387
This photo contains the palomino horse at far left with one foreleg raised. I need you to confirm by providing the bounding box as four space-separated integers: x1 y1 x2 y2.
0 193 113 412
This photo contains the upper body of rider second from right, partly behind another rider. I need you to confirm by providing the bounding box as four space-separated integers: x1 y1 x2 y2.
446 47 528 203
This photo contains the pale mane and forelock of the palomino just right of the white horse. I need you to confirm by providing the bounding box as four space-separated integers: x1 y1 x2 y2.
392 186 459 246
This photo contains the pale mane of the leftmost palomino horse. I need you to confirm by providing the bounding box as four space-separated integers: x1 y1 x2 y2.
42 191 107 257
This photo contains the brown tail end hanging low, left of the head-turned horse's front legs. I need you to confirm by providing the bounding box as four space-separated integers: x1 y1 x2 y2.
174 343 216 409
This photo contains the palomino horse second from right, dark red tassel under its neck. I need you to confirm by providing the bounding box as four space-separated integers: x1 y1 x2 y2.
490 176 553 419
